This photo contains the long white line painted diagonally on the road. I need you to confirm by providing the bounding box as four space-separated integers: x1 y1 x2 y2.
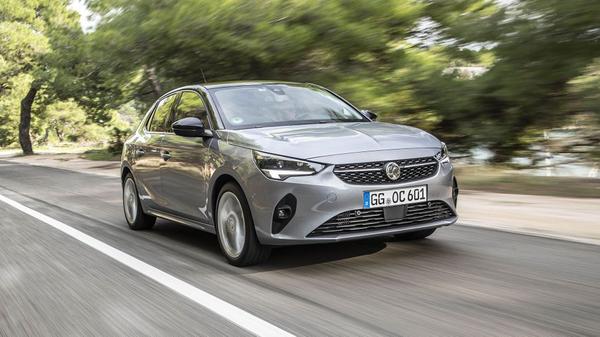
0 195 294 337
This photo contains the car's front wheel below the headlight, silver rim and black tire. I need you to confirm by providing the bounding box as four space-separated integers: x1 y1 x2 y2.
215 183 271 267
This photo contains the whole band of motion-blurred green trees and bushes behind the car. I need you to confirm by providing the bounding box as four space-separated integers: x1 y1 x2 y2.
0 0 600 164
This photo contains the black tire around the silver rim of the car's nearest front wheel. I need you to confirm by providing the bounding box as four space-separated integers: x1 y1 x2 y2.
214 182 271 267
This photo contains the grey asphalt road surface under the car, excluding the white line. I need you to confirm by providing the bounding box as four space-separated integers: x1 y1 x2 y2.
0 161 600 337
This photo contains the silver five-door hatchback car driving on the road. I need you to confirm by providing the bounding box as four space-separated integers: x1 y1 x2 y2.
122 82 458 266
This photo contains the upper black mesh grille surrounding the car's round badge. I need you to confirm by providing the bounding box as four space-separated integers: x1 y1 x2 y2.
333 157 439 185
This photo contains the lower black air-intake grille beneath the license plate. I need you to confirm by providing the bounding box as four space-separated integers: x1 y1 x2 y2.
308 200 455 237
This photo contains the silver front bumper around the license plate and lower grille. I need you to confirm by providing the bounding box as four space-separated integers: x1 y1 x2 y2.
244 150 457 245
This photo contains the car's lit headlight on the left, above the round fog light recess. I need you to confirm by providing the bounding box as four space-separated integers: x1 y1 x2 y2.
252 151 325 180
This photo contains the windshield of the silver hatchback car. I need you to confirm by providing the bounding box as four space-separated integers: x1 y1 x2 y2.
211 84 368 129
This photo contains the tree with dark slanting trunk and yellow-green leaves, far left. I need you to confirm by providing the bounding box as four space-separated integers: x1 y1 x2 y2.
0 0 81 154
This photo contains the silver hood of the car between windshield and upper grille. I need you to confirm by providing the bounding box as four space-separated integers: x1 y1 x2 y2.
222 122 441 159
